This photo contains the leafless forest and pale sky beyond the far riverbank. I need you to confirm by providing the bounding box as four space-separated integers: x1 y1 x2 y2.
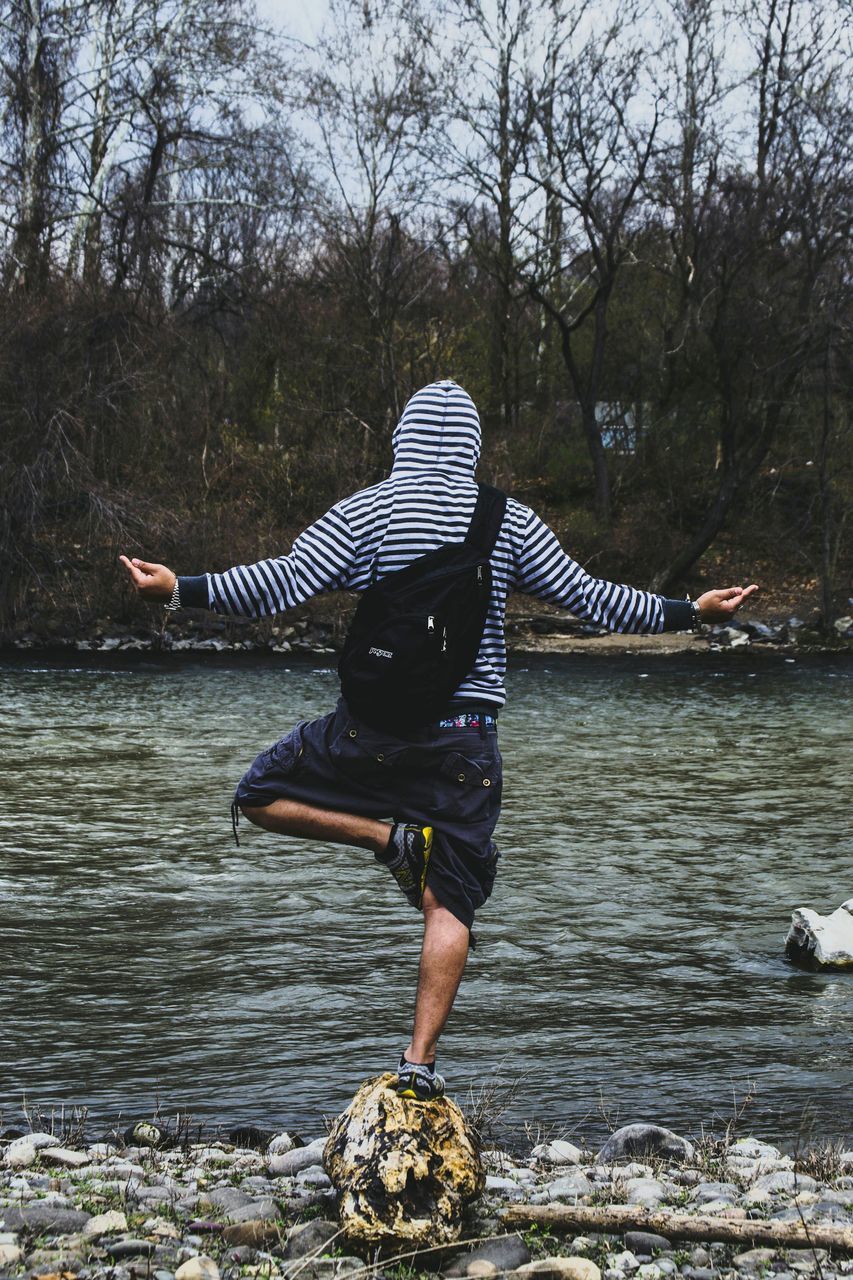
0 0 853 636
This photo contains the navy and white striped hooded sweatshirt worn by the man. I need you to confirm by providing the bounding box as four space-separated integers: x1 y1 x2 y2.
178 381 692 707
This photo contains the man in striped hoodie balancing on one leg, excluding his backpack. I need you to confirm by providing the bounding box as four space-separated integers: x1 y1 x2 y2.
120 380 757 1100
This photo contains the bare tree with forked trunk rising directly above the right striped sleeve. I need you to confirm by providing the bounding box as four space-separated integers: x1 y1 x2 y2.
525 5 658 522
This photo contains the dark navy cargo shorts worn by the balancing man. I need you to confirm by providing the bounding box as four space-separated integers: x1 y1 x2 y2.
234 699 502 929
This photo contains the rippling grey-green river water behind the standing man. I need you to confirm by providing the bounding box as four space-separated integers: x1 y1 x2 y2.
0 654 853 1144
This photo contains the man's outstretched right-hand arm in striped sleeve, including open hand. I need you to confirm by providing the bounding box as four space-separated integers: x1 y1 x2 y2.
514 511 758 634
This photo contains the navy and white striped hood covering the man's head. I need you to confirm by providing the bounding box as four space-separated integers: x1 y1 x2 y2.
391 379 480 479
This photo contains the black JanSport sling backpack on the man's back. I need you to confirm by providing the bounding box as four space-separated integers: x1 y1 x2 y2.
338 484 506 733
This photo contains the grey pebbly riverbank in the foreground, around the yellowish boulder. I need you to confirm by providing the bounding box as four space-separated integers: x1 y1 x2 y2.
0 1121 853 1280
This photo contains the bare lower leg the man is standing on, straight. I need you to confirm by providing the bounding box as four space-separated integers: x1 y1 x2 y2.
405 887 469 1062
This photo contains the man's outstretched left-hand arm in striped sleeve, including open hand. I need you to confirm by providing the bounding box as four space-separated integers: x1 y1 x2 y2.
119 507 356 618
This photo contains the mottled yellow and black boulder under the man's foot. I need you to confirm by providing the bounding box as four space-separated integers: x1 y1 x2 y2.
324 1073 485 1244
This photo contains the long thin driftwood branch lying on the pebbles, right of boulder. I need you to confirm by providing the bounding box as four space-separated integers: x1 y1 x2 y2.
500 1204 853 1253
